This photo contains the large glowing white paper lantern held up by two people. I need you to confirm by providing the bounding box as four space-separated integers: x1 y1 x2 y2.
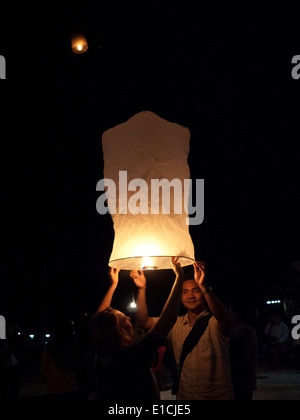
102 111 195 270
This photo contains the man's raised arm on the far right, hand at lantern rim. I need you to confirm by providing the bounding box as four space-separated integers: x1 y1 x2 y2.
194 261 231 337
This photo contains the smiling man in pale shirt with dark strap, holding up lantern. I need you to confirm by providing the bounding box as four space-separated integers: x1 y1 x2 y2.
131 262 234 400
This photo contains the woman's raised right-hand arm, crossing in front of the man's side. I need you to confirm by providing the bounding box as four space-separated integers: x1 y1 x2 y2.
146 257 184 338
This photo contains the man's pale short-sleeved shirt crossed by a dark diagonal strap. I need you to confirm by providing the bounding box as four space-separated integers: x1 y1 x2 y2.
168 311 234 400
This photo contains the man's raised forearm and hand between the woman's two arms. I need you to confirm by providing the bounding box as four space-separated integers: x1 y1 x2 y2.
130 270 155 330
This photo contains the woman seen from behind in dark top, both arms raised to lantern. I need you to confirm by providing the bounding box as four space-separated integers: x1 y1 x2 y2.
91 258 184 400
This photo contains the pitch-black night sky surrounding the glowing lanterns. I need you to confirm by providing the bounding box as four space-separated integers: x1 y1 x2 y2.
0 1 300 322
